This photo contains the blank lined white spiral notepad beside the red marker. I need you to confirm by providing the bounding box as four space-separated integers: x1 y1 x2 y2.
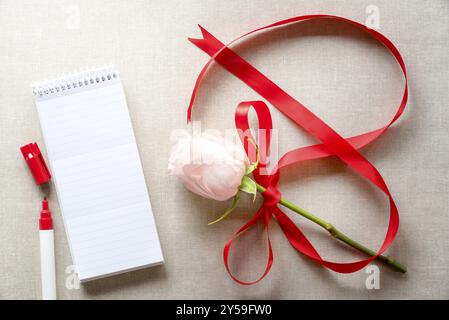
33 68 163 281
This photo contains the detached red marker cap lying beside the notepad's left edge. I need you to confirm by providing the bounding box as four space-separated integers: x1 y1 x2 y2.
20 142 51 185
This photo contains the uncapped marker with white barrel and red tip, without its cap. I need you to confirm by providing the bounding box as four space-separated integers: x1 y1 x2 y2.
39 198 56 300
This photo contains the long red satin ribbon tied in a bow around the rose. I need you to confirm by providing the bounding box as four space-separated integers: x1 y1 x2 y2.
187 15 408 285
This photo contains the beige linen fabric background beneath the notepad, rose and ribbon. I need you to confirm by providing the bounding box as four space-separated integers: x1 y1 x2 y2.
0 0 449 299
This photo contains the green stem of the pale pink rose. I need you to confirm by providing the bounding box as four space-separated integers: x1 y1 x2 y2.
256 183 407 273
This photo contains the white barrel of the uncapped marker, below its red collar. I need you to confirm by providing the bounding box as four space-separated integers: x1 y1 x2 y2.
39 230 56 300
